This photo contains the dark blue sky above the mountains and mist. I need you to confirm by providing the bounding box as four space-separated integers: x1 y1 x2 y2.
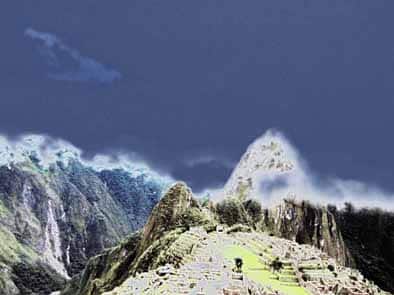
0 0 394 190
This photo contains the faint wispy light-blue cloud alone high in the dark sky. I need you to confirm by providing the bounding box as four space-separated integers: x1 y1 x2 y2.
25 28 121 83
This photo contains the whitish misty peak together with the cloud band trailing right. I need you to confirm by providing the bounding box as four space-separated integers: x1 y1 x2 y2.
215 130 394 211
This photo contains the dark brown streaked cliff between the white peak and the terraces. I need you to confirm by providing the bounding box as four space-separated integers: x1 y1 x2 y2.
216 198 352 265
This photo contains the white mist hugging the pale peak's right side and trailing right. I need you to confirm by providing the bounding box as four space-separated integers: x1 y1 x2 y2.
252 130 394 211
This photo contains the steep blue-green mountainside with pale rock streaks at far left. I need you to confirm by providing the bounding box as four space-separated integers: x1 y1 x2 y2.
0 158 168 295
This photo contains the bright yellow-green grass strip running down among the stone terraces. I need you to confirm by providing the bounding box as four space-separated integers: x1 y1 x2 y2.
223 245 309 295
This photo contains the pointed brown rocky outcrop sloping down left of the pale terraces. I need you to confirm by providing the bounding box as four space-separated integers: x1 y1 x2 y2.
63 183 214 295
